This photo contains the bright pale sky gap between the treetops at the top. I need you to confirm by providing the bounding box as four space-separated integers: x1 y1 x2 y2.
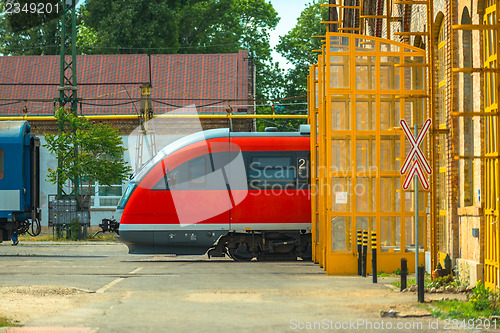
269 0 312 69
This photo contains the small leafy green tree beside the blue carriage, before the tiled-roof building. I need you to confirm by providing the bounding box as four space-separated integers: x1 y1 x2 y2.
45 108 132 206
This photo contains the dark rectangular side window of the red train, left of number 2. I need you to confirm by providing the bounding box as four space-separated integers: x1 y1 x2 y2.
248 156 297 189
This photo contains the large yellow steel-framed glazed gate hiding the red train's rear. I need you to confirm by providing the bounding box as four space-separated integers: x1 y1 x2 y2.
309 32 428 274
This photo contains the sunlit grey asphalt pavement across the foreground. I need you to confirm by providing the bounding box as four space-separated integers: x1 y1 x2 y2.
0 242 472 332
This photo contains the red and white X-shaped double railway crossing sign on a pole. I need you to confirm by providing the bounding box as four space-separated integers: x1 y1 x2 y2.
400 119 432 190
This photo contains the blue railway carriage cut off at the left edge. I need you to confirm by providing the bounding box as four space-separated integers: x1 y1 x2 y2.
0 121 40 242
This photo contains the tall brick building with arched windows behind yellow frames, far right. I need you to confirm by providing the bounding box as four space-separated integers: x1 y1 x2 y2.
404 0 486 284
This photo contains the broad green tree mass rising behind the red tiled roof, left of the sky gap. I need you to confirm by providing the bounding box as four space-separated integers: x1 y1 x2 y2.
80 0 279 98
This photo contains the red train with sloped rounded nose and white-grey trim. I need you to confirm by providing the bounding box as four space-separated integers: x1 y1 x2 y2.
117 125 311 260
